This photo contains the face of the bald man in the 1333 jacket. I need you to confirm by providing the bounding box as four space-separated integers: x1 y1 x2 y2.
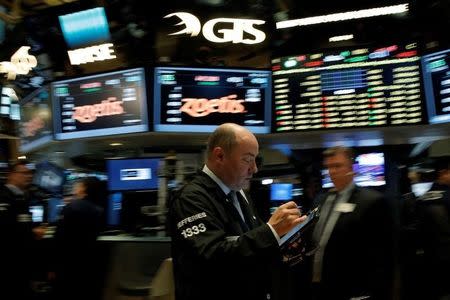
222 134 258 190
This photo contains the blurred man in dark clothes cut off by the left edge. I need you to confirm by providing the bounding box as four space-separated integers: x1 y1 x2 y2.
0 161 33 299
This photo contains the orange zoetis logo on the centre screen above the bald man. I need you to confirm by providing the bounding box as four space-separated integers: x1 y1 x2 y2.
180 95 247 118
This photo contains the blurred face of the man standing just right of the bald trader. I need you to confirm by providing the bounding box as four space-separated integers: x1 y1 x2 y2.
324 152 353 191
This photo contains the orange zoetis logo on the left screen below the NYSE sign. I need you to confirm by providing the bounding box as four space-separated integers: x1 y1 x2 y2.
72 97 125 123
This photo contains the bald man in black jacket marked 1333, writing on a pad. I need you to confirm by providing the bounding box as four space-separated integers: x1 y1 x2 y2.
169 123 305 300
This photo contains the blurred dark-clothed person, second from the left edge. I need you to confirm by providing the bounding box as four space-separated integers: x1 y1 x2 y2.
51 177 107 299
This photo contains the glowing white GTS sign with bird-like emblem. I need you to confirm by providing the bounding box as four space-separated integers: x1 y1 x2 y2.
164 12 266 44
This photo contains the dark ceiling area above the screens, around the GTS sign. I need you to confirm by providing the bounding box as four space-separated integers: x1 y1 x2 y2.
0 0 450 95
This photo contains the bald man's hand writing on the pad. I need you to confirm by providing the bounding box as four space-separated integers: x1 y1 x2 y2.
268 201 306 237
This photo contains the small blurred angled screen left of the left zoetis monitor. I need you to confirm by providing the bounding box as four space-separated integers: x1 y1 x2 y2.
19 87 53 152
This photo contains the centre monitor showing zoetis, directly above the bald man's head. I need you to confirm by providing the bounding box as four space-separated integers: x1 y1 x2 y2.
154 67 272 133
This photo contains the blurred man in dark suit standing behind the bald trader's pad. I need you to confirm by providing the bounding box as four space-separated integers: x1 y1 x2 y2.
311 147 392 300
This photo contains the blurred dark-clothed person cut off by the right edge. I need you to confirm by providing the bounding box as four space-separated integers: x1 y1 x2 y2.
416 156 450 300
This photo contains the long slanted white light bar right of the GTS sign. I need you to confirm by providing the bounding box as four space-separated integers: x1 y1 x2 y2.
276 3 409 29
